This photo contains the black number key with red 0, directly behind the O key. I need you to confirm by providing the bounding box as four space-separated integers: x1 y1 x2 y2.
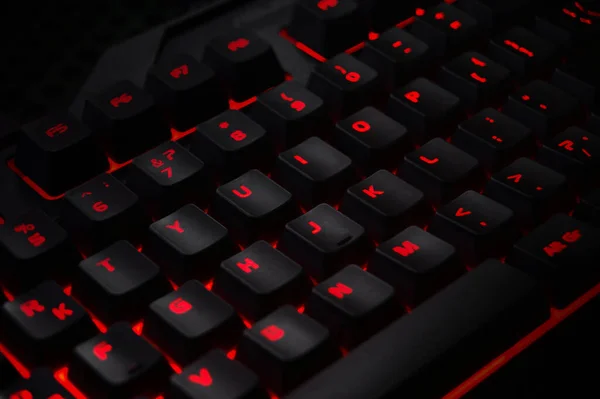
307 53 380 120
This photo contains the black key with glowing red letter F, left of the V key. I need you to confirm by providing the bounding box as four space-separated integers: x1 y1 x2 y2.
69 322 171 399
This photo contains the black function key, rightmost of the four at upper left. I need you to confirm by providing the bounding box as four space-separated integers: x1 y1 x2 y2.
204 29 284 101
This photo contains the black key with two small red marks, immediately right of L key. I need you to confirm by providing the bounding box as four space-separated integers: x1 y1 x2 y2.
452 108 536 171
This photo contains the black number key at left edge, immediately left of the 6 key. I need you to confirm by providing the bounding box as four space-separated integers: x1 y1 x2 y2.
0 209 80 294
